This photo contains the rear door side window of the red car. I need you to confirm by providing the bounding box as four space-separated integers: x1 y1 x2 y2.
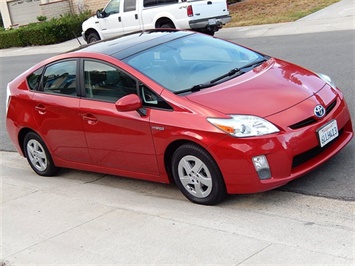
43 60 77 96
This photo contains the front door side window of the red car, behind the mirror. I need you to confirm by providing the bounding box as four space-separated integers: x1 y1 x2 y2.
84 60 137 102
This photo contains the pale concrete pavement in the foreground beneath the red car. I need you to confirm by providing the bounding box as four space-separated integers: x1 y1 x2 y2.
0 152 355 266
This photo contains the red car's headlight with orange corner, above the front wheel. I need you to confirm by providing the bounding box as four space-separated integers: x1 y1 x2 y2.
207 115 280 138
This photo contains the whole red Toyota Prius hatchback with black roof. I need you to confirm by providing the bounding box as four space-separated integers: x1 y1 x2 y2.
6 30 353 204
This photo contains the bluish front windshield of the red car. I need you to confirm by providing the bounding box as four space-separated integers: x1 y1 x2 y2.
124 34 264 94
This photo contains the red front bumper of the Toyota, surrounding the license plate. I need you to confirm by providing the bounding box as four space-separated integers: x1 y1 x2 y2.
209 94 353 194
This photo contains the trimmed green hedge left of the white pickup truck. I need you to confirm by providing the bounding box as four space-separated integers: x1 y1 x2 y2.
0 12 91 49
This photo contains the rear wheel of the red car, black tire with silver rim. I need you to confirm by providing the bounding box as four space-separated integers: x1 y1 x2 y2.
23 132 60 176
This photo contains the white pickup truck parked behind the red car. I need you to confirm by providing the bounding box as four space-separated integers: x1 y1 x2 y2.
82 0 230 43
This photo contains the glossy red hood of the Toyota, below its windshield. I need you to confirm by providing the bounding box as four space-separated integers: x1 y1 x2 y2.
186 58 325 117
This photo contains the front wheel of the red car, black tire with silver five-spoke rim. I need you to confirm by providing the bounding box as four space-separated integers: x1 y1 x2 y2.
172 143 227 205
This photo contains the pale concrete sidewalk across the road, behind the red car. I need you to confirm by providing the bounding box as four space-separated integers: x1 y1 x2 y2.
0 0 355 57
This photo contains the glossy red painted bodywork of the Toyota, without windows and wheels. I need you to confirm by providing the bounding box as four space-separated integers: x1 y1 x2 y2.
6 31 353 197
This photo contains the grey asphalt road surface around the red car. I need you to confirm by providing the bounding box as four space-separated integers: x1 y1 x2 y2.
0 31 355 201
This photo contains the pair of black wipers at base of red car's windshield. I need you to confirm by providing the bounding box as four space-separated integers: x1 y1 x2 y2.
174 56 270 94
